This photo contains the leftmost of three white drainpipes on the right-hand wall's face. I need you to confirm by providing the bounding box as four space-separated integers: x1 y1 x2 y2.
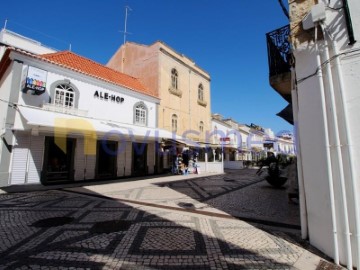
315 25 339 265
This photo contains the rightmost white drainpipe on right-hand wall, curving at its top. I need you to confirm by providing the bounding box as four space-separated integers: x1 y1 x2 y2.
325 24 360 269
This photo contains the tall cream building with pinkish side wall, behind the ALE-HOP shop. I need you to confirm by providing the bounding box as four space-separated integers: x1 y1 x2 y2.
107 41 211 142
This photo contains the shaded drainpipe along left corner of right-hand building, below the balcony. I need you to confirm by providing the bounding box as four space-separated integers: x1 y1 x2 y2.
291 67 309 239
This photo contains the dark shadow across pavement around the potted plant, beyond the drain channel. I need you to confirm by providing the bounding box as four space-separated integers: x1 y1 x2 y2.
152 169 300 230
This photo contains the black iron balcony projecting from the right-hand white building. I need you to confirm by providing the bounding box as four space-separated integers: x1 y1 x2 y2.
266 25 292 102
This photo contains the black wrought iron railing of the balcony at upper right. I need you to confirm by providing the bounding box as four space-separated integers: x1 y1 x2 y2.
266 25 291 76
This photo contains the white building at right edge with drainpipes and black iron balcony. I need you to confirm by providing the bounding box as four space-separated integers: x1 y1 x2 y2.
268 0 360 269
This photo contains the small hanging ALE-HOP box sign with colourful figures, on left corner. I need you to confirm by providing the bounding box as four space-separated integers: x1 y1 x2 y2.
23 66 47 95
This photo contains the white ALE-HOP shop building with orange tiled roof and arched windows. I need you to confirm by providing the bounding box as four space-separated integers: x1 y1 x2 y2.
0 48 176 186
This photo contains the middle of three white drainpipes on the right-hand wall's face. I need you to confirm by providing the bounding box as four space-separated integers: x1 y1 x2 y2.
320 24 352 269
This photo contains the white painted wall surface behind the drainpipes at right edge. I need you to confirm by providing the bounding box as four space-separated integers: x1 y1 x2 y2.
294 0 360 266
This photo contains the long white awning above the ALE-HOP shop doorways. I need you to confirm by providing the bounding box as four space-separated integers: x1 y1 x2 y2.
14 106 177 140
